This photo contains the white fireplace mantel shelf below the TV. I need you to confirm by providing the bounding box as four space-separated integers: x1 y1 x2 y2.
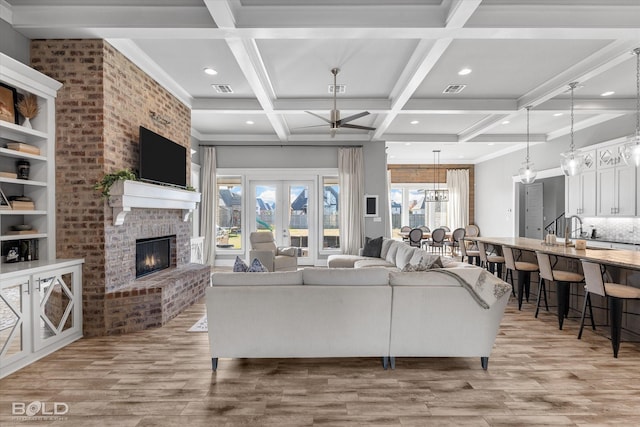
109 181 200 225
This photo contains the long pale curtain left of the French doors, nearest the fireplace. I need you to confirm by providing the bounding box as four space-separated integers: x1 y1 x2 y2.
200 146 218 266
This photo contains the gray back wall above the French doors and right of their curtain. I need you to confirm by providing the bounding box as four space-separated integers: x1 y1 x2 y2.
211 141 389 237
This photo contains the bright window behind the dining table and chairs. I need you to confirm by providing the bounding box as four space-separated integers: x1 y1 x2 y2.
389 183 449 238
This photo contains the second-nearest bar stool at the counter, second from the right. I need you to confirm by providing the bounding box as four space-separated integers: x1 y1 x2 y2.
535 251 584 330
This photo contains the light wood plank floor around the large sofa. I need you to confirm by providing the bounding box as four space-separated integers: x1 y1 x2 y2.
0 298 640 427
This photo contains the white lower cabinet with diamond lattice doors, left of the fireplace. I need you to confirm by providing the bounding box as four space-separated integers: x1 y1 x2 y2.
0 260 82 378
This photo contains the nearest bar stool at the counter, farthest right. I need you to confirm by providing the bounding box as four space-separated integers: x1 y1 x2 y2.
578 260 640 358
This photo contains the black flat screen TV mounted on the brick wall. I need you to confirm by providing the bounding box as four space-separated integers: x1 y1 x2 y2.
138 126 187 188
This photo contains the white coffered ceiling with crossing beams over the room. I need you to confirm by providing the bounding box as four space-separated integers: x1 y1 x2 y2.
0 0 640 163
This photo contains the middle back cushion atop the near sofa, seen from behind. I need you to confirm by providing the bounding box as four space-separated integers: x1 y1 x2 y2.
302 267 389 286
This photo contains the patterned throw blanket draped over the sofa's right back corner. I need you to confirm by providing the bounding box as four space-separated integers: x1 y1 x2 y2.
430 268 511 310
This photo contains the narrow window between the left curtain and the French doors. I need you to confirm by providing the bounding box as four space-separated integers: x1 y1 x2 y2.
216 176 243 250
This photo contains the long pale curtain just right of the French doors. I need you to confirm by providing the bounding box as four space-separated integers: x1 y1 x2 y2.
338 147 364 255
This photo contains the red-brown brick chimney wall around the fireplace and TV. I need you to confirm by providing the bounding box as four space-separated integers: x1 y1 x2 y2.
31 40 191 336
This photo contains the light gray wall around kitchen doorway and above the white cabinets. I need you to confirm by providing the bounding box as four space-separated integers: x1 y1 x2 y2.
475 115 635 237
